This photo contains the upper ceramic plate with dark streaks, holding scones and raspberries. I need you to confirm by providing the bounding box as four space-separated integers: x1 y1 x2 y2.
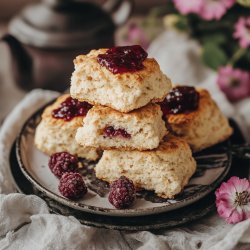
16 103 231 217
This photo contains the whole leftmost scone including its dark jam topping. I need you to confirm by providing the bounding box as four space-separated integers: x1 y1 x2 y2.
35 94 100 160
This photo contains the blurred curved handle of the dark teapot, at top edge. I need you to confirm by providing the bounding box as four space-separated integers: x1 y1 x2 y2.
103 0 134 26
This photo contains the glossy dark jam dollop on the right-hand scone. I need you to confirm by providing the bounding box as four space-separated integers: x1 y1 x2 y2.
160 86 199 115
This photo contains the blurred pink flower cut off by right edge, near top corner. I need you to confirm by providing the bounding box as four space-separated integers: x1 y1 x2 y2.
233 17 250 48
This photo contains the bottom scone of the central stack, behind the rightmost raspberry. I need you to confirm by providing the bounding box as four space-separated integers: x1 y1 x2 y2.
95 137 196 198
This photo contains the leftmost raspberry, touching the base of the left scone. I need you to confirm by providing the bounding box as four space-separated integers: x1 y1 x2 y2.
49 152 78 178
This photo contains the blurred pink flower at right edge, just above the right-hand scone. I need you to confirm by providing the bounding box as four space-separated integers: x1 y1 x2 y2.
217 66 250 101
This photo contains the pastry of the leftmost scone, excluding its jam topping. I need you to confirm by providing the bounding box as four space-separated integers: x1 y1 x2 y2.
35 95 99 160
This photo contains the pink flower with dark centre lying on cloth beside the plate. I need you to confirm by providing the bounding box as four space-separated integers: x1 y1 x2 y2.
215 176 250 224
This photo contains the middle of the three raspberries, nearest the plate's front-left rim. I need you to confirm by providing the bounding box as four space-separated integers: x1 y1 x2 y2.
58 172 87 200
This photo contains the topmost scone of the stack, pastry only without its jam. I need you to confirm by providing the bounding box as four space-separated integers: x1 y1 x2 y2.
70 49 171 113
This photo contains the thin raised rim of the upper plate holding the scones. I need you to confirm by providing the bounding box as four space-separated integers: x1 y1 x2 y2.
16 98 232 217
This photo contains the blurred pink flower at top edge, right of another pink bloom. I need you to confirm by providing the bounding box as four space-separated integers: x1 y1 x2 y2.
198 0 235 20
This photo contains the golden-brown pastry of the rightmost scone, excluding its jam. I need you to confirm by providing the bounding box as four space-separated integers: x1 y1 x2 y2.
162 88 233 152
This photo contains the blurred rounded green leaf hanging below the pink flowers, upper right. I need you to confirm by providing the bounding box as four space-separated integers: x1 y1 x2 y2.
202 42 228 70
